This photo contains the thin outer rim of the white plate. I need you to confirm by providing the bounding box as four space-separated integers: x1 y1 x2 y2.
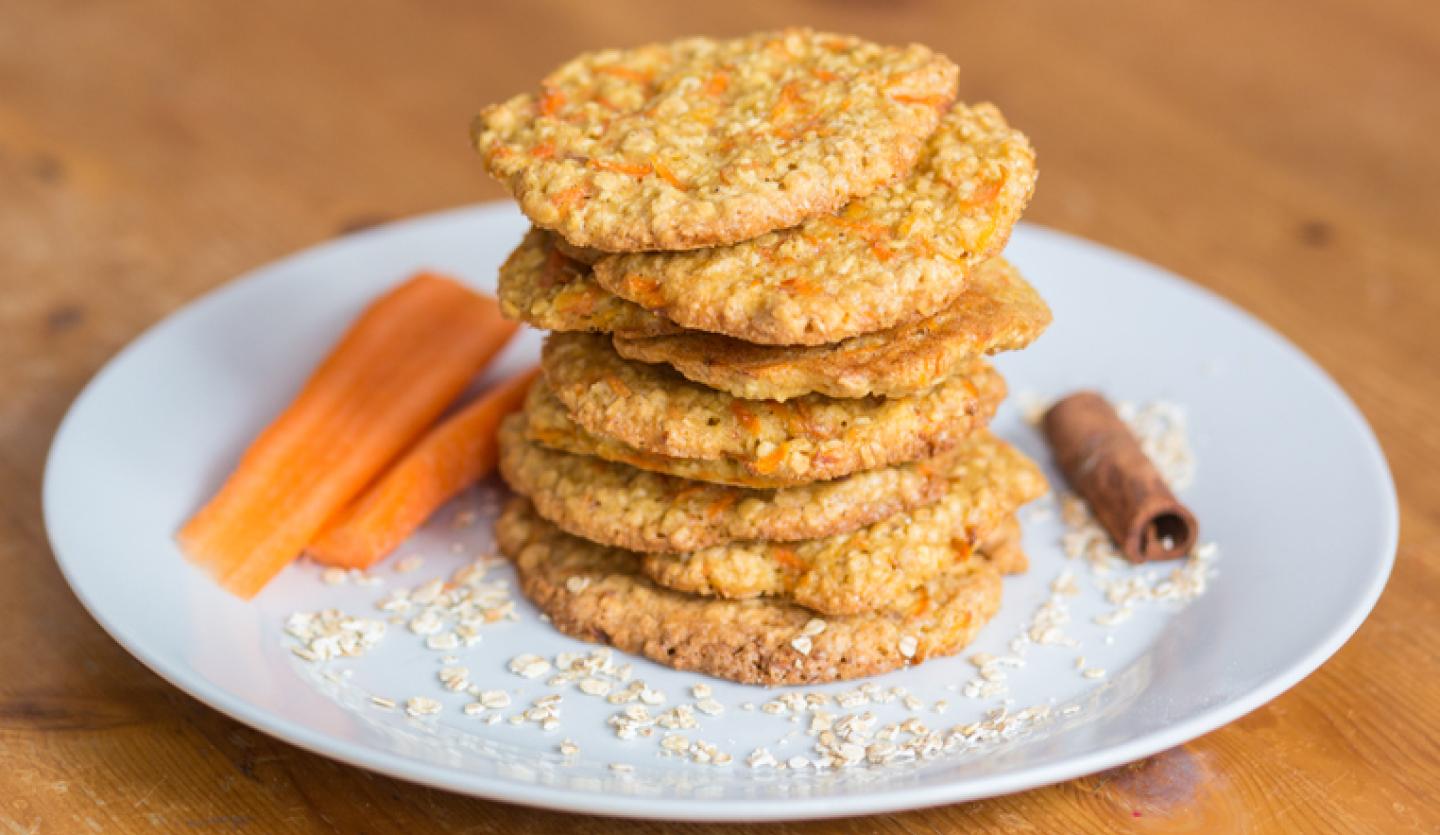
42 200 1400 822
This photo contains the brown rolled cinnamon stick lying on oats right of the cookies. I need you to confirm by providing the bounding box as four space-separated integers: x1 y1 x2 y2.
1044 392 1200 563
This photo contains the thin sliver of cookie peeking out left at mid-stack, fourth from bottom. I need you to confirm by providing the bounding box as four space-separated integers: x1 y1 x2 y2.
526 377 811 489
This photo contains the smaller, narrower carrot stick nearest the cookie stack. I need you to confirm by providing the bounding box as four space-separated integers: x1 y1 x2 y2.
305 369 540 569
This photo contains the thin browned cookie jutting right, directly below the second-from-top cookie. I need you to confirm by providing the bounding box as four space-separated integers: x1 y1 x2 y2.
613 258 1050 400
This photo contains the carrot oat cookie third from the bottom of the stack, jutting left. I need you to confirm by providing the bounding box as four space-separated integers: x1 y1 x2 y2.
500 415 965 553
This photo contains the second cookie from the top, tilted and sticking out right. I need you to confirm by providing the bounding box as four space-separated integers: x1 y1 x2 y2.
595 105 1035 346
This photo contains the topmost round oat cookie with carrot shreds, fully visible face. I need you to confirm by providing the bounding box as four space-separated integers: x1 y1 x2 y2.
472 29 959 252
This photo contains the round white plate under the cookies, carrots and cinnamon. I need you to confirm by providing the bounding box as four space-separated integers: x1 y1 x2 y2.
45 206 1398 819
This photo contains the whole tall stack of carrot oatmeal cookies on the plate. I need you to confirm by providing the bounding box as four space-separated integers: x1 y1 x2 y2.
474 29 1050 684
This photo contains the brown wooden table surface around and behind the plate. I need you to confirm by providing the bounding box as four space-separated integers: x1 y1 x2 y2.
0 0 1440 834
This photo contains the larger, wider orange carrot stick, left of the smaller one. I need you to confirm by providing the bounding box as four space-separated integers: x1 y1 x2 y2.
176 274 516 597
